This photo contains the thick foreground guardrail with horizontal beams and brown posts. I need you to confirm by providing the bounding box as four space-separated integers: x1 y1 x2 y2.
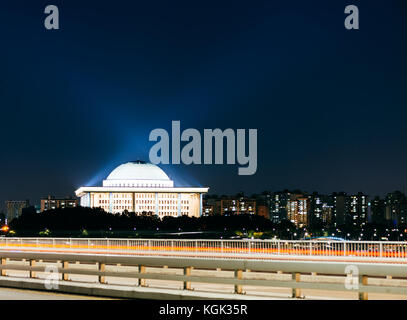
0 251 407 300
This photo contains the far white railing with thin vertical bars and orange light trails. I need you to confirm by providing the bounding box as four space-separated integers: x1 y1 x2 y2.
0 237 407 261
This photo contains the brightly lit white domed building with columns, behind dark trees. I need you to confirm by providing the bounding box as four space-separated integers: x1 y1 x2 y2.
75 161 209 218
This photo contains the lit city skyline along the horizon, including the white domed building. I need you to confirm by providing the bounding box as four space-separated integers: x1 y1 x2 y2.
1 160 407 240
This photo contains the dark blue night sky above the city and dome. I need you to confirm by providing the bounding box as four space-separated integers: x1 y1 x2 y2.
0 0 407 206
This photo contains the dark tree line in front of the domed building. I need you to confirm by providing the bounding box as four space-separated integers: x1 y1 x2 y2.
9 207 286 236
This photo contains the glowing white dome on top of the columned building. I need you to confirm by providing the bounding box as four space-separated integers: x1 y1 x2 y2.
103 160 174 188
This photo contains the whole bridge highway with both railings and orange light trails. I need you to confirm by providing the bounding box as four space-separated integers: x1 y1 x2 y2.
0 238 407 300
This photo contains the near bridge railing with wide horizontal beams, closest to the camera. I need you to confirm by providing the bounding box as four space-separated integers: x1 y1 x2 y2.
0 250 407 300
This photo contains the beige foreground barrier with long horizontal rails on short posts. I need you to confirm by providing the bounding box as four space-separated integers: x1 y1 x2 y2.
0 250 407 300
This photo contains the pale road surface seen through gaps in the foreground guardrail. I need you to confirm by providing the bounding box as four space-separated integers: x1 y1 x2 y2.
0 261 407 300
